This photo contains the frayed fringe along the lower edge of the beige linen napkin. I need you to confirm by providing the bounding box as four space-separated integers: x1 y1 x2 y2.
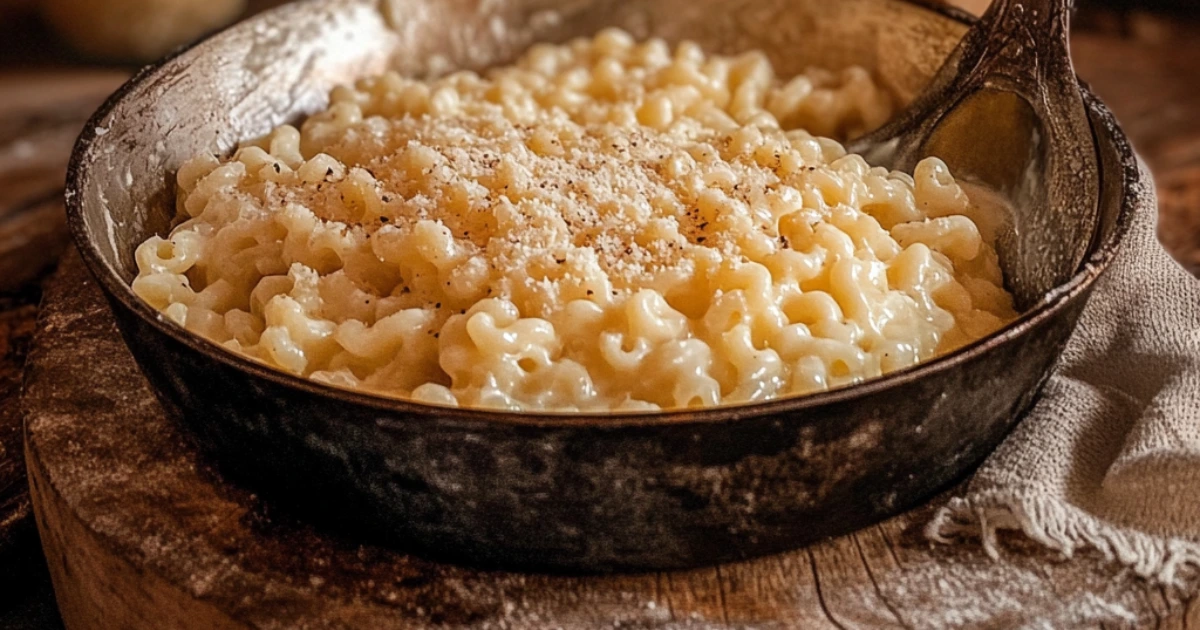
925 491 1200 586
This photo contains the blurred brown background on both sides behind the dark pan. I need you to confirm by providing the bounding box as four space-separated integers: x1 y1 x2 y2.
0 0 1200 630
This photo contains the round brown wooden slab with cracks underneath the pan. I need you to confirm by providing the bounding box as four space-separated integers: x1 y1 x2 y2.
23 256 1200 630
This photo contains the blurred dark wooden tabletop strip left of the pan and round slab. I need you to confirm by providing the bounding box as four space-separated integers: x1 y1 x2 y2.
0 41 128 630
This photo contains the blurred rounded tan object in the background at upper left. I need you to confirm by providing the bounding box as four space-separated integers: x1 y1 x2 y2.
41 0 246 61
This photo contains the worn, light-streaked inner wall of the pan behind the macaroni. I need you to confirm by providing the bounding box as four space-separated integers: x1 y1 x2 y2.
73 0 965 282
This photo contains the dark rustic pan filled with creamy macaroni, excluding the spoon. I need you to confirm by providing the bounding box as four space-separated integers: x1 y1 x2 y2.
67 0 1142 571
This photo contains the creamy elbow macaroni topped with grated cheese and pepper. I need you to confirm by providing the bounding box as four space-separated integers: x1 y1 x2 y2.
133 30 1015 412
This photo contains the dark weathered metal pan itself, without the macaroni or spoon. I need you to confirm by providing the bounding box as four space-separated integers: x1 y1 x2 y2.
66 0 1141 571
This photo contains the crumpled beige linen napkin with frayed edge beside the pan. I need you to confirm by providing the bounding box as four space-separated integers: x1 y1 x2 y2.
925 167 1200 586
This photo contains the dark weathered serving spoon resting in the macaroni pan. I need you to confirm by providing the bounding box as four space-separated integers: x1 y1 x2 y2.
848 0 1100 306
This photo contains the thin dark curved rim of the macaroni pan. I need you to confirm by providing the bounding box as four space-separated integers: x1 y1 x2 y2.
64 0 1142 430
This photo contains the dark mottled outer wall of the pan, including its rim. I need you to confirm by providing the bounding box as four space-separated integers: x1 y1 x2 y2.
67 0 1142 572
